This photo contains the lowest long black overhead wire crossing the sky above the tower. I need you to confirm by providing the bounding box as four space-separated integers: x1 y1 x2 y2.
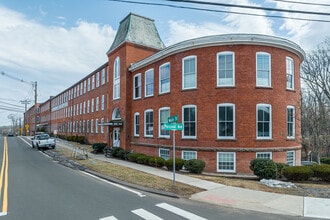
108 0 330 22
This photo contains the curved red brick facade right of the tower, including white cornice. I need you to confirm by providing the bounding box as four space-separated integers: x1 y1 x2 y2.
130 35 303 173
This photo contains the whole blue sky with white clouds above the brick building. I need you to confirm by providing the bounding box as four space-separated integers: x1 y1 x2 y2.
0 0 330 126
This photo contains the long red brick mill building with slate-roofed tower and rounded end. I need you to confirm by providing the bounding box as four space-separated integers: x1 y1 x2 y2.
31 14 304 173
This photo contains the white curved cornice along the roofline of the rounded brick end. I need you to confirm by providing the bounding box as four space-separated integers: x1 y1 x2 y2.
129 34 305 71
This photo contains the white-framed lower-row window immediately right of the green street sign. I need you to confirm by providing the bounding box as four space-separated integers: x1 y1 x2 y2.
182 105 196 138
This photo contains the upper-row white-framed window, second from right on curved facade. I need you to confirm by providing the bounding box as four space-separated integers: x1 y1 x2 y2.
256 52 271 87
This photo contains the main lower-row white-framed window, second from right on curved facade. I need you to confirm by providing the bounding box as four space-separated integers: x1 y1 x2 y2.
257 104 272 139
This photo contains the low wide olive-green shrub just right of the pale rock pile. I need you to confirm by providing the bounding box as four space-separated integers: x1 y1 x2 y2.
282 166 313 181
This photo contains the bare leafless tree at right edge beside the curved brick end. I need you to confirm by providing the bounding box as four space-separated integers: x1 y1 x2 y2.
301 38 330 163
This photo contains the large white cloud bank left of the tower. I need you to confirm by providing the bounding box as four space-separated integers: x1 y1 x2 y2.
0 7 116 124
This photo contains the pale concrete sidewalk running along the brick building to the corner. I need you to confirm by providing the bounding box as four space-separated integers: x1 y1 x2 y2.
57 140 330 219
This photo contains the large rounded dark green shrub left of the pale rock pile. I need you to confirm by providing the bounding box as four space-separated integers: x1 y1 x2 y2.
250 158 277 180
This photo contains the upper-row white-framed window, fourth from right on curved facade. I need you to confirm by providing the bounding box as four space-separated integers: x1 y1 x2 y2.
182 56 197 89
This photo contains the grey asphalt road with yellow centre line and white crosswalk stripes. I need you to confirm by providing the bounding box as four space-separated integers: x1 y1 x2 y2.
0 137 314 220
